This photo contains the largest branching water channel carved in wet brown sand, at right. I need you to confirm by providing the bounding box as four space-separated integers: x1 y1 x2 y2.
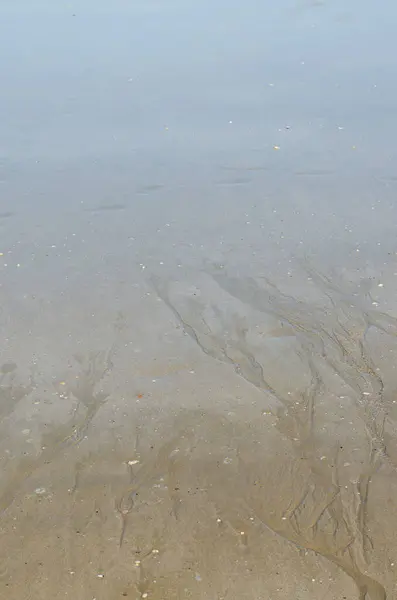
150 267 397 600
